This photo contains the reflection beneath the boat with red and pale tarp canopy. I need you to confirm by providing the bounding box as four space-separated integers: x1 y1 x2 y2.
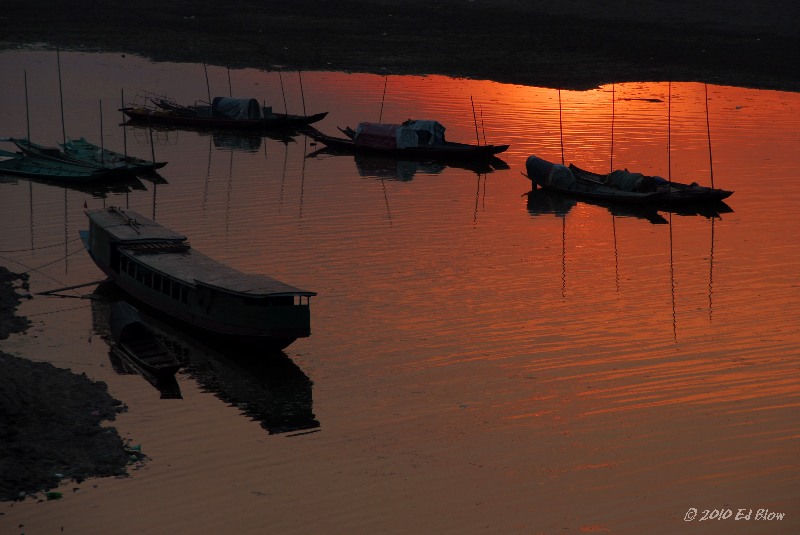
306 147 509 182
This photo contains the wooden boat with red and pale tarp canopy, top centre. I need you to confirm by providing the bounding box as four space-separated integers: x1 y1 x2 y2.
306 120 508 161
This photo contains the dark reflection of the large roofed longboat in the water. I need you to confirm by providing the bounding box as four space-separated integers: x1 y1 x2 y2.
93 282 320 434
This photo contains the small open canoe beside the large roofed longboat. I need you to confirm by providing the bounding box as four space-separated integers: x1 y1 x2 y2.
109 301 181 381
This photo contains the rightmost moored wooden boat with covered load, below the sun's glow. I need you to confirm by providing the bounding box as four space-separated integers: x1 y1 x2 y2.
525 156 733 208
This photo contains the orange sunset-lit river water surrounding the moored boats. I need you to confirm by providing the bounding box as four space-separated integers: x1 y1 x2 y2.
0 51 800 534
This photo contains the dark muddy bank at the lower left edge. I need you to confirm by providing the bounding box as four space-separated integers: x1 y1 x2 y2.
0 266 131 502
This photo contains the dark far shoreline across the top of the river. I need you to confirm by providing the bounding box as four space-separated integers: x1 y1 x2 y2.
0 0 800 91
